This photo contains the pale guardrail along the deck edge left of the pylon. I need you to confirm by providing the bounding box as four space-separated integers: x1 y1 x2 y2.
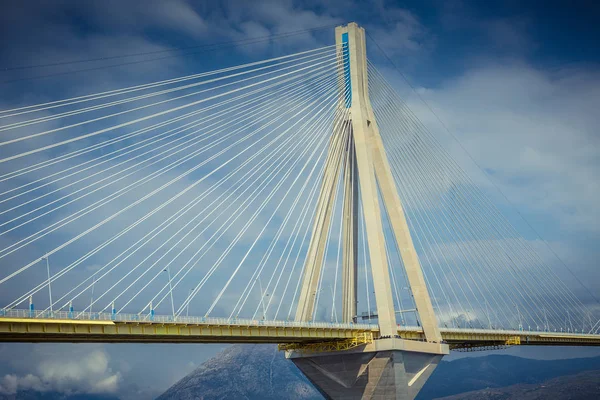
0 309 379 330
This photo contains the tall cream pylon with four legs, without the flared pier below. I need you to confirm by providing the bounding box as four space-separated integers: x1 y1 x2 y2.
296 23 441 343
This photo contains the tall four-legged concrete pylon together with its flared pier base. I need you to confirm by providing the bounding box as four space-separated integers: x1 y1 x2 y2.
286 23 449 400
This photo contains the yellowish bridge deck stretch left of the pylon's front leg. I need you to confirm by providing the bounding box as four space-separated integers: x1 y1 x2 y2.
0 310 379 343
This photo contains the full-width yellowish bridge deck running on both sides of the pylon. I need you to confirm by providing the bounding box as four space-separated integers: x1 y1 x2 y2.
0 310 600 349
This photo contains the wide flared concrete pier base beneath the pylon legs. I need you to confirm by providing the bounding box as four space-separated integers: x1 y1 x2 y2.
286 338 449 400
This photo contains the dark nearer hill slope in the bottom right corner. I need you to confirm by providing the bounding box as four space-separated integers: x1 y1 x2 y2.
440 371 600 400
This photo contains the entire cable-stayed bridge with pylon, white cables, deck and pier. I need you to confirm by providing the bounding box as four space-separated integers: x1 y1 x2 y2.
0 24 600 398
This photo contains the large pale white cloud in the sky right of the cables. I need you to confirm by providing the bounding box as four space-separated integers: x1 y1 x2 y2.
412 63 600 233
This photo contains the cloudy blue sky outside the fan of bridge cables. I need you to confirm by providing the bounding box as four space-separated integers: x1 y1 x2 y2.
0 0 600 398
